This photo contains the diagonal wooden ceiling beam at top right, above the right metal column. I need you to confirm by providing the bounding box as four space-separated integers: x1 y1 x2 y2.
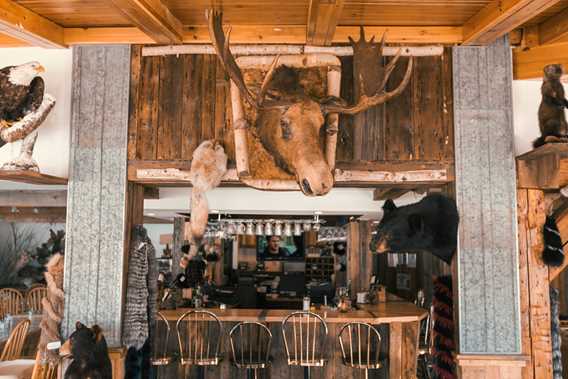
463 0 560 45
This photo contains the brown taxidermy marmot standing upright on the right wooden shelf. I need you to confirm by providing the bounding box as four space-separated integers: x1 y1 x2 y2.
533 64 568 148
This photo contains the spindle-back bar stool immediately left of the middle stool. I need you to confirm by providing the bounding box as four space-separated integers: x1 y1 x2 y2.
176 310 222 376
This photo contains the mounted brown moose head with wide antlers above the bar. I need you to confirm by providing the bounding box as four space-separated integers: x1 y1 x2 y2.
207 10 413 196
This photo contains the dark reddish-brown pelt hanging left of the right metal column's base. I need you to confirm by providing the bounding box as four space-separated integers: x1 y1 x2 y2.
432 276 457 379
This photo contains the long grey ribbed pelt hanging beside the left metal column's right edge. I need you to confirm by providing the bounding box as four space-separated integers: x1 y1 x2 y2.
122 225 158 349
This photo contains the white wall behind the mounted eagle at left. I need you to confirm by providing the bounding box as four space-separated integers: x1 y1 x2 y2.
0 47 73 178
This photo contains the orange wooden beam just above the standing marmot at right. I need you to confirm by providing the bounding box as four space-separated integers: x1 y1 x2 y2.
513 42 568 80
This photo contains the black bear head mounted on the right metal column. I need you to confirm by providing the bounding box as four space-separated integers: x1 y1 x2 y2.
370 194 459 264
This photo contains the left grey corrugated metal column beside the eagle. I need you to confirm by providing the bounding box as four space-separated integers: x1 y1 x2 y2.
63 45 130 347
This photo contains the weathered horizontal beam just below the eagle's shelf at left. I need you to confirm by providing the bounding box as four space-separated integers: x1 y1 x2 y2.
0 190 67 208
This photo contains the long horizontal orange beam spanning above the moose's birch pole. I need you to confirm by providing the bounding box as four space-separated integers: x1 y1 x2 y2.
60 25 463 45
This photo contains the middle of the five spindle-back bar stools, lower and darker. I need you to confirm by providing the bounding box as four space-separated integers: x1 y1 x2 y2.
229 322 272 379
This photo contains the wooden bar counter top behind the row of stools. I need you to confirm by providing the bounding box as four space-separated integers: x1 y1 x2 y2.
161 301 427 325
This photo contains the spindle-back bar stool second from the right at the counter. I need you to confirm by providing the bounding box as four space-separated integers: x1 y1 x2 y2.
282 311 328 378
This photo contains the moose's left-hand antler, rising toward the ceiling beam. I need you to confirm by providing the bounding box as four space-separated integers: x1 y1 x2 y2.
205 9 280 109
